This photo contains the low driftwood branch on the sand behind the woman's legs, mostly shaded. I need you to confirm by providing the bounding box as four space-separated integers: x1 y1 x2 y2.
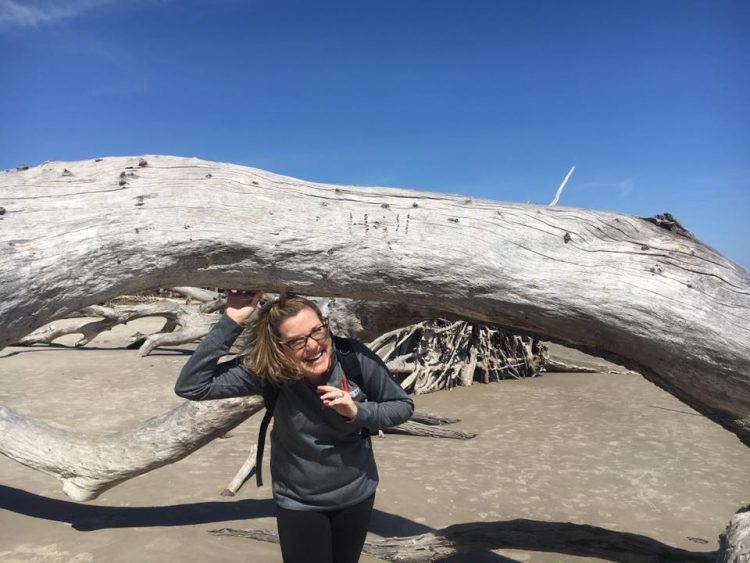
209 519 716 563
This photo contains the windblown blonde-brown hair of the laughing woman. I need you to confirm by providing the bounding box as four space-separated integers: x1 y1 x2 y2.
243 293 325 387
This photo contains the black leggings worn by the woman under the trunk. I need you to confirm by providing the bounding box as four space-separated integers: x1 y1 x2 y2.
276 493 375 563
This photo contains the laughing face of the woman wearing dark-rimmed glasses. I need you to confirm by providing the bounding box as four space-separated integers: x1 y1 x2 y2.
279 307 333 384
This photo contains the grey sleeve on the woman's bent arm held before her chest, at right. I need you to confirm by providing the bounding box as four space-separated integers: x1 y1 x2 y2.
352 341 414 431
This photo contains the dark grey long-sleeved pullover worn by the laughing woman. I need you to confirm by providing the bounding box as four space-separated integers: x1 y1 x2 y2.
175 315 414 510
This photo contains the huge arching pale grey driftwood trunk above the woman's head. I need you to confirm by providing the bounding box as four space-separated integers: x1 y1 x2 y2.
0 156 750 445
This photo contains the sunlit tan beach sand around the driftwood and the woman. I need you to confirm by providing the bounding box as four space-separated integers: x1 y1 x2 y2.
0 321 750 563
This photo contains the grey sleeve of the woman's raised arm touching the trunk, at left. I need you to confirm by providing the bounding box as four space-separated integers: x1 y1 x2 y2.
174 315 263 401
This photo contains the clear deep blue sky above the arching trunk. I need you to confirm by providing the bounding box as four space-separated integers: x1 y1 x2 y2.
0 0 750 268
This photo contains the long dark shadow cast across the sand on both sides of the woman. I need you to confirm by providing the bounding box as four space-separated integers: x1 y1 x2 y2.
0 485 717 563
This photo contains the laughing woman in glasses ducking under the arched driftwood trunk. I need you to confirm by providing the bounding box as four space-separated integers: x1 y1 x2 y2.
175 292 414 563
